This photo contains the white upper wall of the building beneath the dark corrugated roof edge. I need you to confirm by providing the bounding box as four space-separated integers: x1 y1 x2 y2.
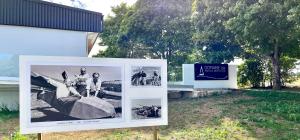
0 25 87 56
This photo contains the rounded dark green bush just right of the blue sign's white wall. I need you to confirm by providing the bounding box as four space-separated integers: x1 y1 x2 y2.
238 59 264 88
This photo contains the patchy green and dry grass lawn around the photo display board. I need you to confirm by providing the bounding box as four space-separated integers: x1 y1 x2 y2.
0 91 300 140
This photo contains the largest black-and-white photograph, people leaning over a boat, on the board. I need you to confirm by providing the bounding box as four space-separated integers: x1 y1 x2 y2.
31 65 122 122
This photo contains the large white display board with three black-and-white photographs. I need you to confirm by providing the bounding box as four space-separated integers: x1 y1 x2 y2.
20 56 168 134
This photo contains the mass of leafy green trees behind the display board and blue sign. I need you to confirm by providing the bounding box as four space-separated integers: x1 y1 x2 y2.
96 0 300 84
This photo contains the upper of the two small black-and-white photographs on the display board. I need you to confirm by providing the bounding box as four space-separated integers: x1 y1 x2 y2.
131 66 161 87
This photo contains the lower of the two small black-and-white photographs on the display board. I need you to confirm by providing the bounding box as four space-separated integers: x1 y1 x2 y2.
131 99 161 120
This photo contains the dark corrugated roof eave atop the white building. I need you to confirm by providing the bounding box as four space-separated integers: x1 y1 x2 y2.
0 0 103 32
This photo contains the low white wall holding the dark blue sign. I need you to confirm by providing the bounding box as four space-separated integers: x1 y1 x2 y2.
182 64 238 89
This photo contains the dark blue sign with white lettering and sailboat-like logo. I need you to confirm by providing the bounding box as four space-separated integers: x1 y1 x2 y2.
194 64 228 80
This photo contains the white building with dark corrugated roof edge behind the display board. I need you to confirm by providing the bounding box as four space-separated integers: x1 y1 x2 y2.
0 0 103 110
